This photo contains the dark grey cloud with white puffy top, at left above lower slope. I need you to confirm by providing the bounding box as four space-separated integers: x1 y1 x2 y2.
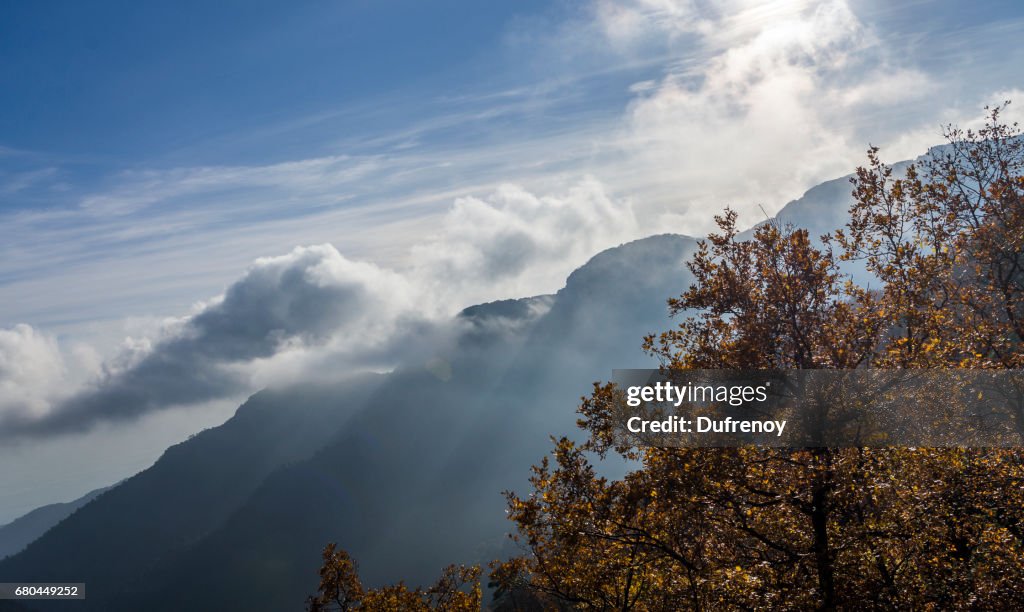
0 245 413 436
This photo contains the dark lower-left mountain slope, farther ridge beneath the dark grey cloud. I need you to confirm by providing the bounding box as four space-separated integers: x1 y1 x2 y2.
0 377 376 610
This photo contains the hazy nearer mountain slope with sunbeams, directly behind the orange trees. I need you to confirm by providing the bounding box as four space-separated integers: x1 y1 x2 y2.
94 235 695 610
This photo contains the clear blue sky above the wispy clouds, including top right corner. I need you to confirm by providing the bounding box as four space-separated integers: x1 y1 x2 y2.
0 0 1021 175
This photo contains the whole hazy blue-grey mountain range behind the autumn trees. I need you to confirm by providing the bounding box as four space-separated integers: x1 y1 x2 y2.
0 165 884 611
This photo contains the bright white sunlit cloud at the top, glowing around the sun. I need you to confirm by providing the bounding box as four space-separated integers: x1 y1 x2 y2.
599 0 933 233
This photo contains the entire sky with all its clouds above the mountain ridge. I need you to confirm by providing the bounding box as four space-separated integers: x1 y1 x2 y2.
0 0 1024 523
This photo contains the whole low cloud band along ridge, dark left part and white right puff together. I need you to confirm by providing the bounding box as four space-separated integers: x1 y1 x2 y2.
0 178 637 438
